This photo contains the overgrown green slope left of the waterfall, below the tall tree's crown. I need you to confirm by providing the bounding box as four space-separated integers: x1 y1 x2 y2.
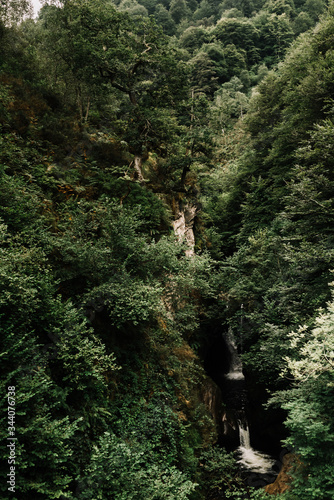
0 43 219 499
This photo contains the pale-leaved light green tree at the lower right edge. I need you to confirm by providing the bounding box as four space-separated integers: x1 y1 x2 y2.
268 292 334 499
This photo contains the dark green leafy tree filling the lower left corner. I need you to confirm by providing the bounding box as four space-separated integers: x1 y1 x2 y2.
0 225 116 498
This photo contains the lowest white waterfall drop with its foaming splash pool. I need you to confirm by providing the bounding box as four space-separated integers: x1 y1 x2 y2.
238 420 275 474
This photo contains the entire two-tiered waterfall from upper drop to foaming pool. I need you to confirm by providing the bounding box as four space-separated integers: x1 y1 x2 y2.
224 330 275 474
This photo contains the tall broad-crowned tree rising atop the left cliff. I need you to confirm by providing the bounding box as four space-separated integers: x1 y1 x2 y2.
39 0 187 172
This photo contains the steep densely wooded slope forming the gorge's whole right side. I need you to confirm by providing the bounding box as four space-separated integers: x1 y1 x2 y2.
198 5 333 499
